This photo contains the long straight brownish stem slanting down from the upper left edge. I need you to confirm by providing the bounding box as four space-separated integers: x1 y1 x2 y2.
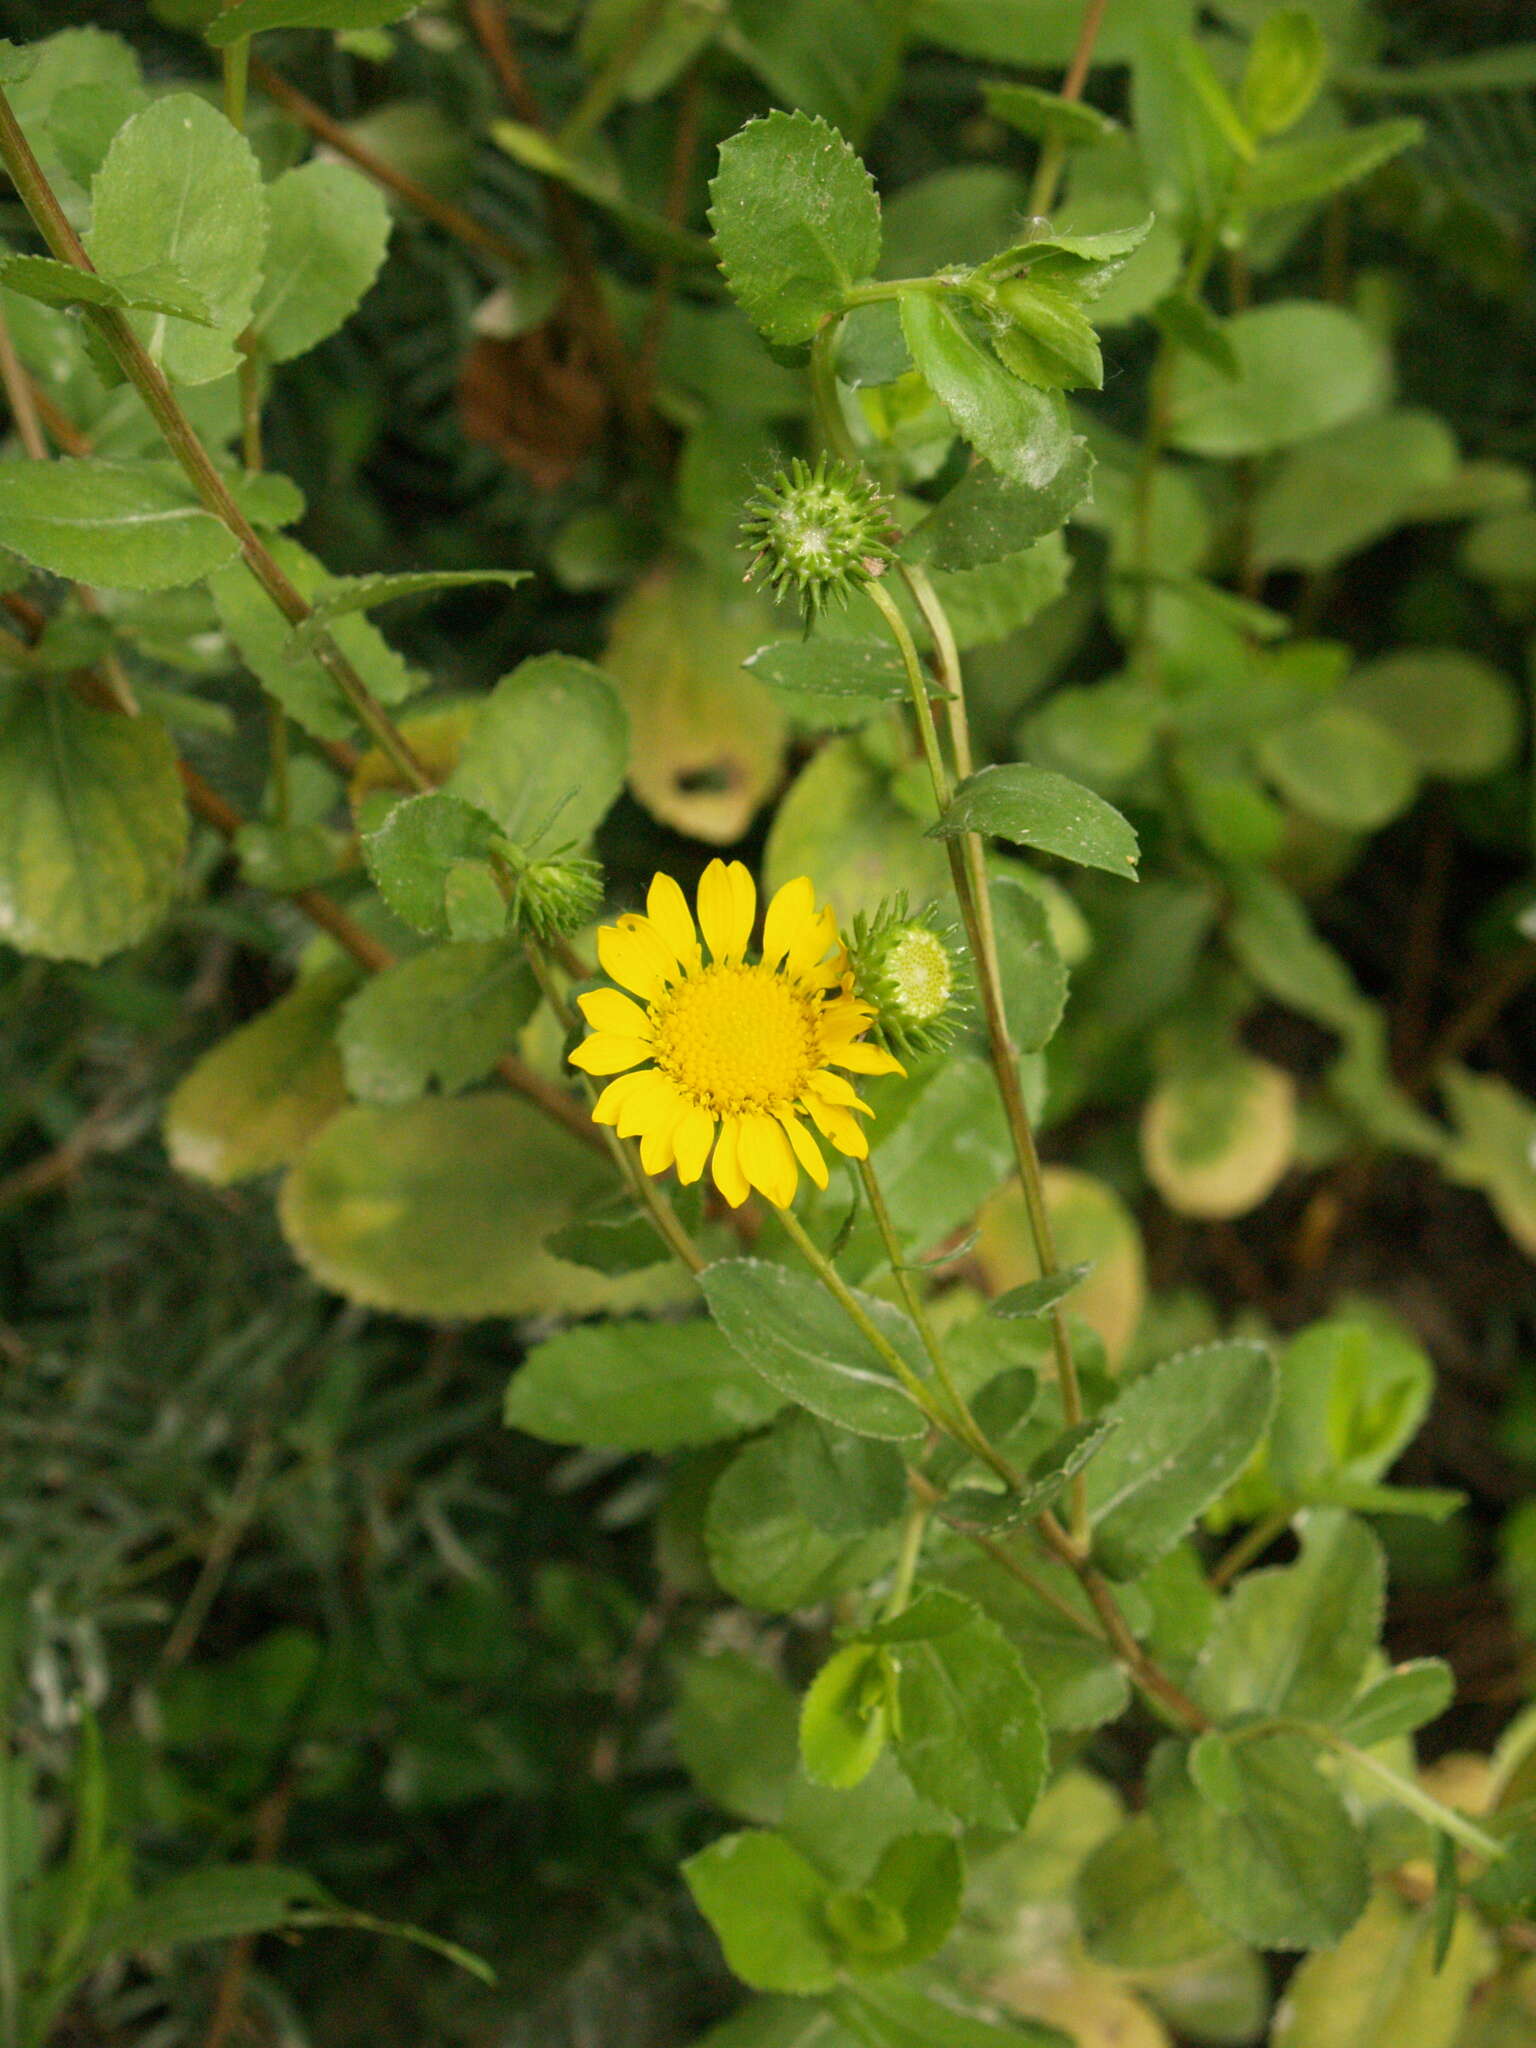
0 88 434 791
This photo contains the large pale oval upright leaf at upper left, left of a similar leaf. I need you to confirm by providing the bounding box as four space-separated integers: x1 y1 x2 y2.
86 92 266 385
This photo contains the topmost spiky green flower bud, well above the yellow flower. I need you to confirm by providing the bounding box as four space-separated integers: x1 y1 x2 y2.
741 455 897 618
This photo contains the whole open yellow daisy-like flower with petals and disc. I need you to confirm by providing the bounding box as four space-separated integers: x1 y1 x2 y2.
571 860 903 1208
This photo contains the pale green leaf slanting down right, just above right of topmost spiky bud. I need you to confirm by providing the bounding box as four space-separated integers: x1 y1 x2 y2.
901 291 1075 492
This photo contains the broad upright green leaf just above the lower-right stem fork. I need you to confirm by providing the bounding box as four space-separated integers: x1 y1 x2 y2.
1194 1509 1386 1720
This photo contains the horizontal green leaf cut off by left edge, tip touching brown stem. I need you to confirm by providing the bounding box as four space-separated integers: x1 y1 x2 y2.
0 457 239 602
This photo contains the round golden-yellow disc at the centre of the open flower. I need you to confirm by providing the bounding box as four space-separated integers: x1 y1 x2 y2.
651 967 821 1116
